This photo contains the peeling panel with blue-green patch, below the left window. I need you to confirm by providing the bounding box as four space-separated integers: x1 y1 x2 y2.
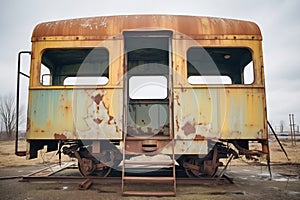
27 88 123 140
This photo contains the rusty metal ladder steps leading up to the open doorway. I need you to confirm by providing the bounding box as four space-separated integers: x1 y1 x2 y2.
122 136 176 196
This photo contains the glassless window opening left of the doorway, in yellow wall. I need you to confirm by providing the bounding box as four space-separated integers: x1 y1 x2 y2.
41 48 109 85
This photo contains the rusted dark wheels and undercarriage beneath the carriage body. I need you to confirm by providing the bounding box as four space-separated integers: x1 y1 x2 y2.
59 140 268 178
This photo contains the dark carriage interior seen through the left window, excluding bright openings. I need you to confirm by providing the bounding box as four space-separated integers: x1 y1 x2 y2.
42 48 109 85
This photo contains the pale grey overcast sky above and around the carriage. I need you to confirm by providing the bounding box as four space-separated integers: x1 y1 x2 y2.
0 0 300 127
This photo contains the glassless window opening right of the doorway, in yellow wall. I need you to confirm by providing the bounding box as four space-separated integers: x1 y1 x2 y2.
187 47 254 84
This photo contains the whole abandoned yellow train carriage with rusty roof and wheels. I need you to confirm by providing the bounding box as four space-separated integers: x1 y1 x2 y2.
16 15 269 195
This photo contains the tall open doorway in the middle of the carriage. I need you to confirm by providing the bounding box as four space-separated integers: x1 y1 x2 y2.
124 31 172 137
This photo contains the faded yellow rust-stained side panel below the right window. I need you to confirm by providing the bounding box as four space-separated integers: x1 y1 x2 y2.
174 88 267 140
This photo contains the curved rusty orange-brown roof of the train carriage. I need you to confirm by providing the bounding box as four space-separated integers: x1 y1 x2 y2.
32 15 262 41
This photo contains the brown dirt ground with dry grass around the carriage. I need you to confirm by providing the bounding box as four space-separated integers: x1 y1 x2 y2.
0 138 300 200
